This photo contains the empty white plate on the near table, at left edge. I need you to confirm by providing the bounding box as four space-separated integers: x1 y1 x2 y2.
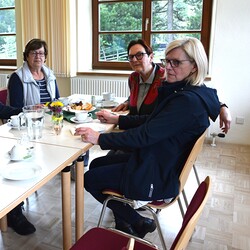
1 162 42 181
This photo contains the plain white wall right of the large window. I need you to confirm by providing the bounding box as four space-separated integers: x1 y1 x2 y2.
211 0 250 144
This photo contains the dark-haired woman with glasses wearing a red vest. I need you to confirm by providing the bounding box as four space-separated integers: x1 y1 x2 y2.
110 39 232 133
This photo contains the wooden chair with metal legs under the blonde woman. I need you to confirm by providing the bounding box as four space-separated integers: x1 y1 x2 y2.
97 131 206 249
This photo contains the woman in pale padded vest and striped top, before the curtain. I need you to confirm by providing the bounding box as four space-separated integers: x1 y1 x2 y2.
7 39 60 107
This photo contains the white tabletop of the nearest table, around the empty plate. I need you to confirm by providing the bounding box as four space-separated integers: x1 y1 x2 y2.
0 138 79 218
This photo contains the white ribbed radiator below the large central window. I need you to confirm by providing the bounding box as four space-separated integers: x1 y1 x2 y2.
70 77 129 98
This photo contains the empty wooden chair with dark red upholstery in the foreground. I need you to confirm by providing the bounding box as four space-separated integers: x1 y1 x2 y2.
71 176 211 250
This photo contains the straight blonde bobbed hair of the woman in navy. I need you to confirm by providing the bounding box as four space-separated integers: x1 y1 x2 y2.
165 37 208 86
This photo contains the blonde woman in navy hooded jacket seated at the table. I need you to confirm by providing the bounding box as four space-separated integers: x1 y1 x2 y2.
76 38 220 238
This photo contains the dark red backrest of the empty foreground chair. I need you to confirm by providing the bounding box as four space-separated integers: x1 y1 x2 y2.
170 176 211 250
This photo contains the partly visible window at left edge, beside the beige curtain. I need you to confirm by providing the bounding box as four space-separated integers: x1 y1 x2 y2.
0 0 16 66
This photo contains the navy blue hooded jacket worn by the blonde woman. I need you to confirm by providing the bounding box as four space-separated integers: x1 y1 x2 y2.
99 81 220 201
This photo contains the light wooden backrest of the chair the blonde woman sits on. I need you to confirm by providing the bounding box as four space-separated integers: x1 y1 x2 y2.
179 129 207 198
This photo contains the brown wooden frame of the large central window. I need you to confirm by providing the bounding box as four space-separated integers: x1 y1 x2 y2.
92 0 213 70
